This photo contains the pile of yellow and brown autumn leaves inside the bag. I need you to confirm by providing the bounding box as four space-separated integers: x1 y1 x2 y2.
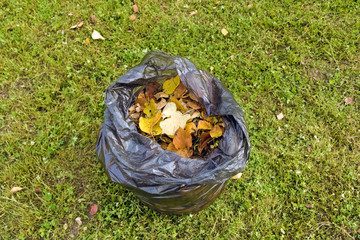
129 76 224 158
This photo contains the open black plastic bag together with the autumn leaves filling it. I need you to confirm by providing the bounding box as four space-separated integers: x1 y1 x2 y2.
96 52 250 214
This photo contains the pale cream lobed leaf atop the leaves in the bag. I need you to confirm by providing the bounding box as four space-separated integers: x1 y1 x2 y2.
160 102 190 137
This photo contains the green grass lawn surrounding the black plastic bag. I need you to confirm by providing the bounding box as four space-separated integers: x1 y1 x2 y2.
0 0 360 239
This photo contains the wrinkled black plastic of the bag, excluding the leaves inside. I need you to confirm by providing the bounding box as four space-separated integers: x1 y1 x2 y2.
96 52 250 214
